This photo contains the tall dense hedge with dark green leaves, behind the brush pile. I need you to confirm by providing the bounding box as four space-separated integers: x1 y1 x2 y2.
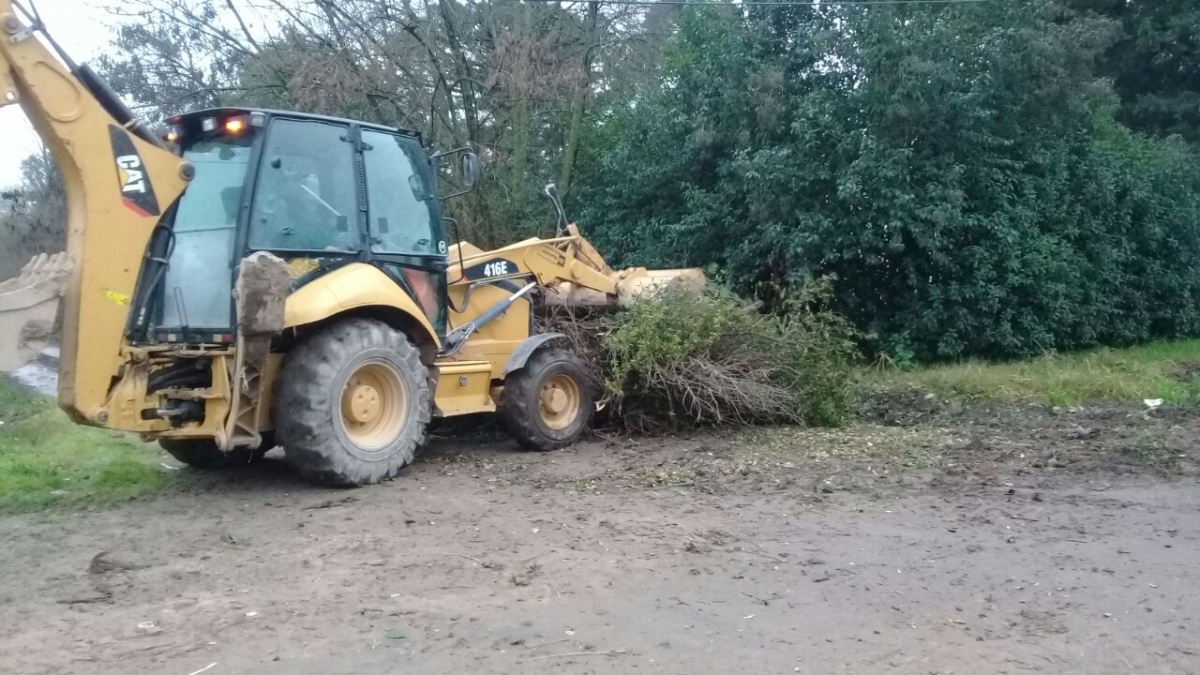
572 0 1200 359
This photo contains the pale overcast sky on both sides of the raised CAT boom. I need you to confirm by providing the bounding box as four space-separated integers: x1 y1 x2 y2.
0 0 114 187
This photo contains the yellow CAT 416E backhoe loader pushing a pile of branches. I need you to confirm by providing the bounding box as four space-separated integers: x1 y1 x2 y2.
0 0 703 484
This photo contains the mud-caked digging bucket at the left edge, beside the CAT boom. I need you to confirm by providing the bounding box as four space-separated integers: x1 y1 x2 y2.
0 253 72 372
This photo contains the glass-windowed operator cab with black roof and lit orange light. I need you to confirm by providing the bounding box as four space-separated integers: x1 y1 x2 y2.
144 108 448 344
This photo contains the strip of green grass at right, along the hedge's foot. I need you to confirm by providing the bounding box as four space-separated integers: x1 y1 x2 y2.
866 340 1200 406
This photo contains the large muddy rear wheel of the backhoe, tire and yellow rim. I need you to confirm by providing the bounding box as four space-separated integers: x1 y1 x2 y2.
275 318 431 485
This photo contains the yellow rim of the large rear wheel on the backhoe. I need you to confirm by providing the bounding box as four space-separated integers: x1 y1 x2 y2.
342 362 408 450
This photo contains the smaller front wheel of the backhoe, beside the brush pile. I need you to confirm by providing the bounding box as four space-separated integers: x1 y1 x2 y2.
502 347 594 452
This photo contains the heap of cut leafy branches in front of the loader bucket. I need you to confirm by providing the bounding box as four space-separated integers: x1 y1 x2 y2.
600 281 854 425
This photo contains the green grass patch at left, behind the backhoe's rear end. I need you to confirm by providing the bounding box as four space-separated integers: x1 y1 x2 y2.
0 376 167 513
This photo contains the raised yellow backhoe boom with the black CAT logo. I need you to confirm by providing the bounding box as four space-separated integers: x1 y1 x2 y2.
0 0 190 425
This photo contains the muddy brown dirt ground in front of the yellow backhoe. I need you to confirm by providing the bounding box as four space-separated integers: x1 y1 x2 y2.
0 396 1200 675
